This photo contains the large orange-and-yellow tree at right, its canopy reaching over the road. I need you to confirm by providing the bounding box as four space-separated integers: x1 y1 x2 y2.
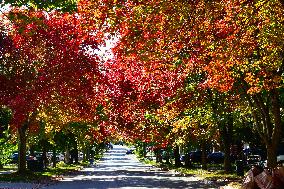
78 0 284 167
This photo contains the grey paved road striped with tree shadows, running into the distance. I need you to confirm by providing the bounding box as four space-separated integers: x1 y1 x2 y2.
0 145 222 189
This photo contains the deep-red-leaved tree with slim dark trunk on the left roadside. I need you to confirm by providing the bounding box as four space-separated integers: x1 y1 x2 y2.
0 9 104 172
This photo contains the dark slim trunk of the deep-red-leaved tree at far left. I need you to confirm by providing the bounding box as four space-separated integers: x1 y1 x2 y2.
18 124 28 174
